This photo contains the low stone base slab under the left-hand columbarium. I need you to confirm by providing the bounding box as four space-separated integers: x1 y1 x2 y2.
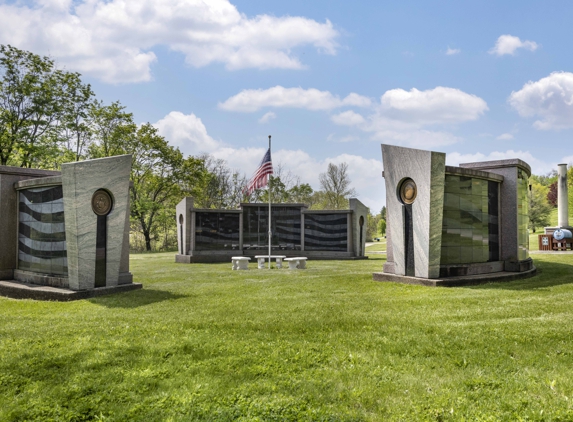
0 280 143 302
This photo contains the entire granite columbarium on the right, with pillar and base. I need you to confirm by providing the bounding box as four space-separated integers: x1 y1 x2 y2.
374 145 535 285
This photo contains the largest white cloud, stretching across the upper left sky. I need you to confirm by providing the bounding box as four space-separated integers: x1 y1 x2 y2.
0 0 339 83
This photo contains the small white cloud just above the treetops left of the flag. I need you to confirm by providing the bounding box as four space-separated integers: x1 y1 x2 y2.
153 111 224 155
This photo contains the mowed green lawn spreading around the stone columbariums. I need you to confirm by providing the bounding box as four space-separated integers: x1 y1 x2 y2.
0 253 573 421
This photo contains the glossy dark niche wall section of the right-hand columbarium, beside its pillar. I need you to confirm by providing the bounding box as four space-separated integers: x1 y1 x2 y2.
440 160 530 276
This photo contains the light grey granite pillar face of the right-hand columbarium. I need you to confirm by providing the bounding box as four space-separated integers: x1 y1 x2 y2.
382 144 445 278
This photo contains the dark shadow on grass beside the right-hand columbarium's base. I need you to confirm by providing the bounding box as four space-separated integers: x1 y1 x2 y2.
470 260 573 290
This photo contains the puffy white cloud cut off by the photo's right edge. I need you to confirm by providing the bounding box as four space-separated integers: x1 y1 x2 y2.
508 72 573 130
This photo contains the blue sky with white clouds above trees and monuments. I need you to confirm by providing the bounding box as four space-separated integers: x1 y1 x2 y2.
0 0 573 212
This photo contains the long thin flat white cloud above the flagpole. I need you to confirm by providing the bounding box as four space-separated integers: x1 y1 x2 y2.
219 85 370 113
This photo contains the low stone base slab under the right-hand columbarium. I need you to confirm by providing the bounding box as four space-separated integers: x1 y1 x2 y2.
372 267 537 287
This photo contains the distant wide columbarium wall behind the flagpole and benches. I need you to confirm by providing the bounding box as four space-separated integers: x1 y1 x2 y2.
175 197 369 263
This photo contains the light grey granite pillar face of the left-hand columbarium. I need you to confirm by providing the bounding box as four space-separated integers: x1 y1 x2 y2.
62 155 131 290
